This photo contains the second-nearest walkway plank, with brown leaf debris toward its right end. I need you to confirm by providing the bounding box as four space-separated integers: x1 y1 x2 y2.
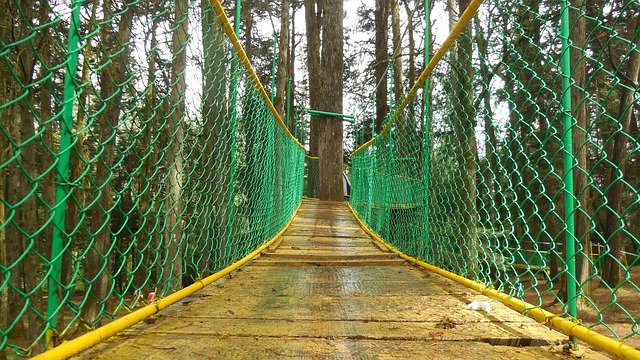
131 317 564 346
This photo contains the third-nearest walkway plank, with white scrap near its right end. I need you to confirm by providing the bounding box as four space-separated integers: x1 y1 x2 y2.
168 292 536 324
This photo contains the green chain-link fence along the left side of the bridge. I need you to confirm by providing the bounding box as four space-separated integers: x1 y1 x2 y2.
0 0 305 358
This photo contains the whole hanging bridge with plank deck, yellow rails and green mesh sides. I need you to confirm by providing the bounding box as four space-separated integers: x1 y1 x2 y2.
0 0 640 359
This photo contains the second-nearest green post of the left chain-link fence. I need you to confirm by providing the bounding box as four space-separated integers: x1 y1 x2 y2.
227 0 242 260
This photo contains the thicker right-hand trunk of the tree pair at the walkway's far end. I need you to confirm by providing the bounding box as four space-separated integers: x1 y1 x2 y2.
319 0 344 201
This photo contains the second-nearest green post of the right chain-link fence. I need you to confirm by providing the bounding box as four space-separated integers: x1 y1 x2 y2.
421 0 431 260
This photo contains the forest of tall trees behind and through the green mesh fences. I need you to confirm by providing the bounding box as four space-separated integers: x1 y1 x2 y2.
0 0 640 359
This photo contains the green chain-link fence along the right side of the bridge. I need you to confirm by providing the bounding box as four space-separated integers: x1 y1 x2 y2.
351 0 640 348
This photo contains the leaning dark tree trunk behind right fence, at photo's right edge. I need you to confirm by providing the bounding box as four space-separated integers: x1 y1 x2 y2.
602 18 640 287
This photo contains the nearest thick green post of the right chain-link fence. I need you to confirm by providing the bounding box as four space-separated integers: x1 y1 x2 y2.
560 0 578 319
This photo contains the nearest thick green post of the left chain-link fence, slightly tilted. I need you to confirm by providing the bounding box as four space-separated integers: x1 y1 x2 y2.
45 0 84 349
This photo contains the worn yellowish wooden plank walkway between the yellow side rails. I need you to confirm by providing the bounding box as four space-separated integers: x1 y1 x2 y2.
80 200 606 360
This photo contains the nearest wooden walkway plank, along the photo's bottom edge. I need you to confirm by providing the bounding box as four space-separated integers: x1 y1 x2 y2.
80 334 603 360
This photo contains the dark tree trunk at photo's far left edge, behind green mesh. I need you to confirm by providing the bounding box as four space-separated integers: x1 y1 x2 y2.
0 1 50 344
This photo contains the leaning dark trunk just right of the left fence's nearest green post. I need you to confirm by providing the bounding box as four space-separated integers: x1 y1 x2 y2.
82 0 134 325
